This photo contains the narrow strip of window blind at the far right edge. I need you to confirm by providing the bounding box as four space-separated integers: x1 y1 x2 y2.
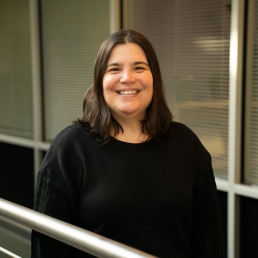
244 1 258 185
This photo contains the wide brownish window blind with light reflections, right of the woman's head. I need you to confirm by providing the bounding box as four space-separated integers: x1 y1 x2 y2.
123 0 231 178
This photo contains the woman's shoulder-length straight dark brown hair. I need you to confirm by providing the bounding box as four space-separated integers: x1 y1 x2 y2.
74 30 173 144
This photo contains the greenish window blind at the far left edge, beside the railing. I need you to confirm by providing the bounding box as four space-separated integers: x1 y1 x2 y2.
0 0 33 139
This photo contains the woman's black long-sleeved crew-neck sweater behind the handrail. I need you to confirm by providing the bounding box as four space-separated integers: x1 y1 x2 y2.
32 122 223 258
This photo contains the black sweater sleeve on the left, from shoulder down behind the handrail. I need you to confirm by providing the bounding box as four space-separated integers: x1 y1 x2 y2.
31 125 95 258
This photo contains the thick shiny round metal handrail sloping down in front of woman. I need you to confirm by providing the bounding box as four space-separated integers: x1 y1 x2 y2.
0 198 154 258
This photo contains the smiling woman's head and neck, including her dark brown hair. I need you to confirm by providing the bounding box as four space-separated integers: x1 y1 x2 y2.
75 30 172 144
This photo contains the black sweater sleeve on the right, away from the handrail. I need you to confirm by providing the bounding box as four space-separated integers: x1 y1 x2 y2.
192 144 225 258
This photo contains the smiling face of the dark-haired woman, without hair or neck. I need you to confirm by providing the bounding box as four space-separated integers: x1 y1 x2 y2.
103 43 153 120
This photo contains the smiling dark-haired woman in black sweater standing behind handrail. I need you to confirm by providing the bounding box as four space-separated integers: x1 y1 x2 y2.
32 30 223 258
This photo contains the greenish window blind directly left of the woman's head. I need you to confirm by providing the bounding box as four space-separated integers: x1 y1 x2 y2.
41 0 110 141
